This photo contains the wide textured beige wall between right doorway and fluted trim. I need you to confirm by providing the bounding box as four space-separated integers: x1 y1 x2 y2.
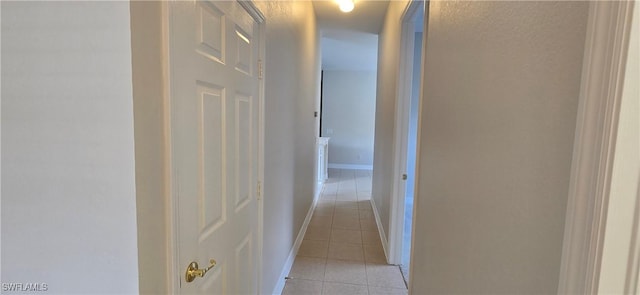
410 1 588 294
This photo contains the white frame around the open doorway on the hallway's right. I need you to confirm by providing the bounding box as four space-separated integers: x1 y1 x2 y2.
387 0 428 264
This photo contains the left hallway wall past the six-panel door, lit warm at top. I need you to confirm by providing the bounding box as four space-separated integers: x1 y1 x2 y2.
256 1 320 294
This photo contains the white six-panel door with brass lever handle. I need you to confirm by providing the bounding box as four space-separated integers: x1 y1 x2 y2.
167 1 261 294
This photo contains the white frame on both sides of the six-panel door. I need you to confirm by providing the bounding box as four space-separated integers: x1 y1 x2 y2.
161 0 267 294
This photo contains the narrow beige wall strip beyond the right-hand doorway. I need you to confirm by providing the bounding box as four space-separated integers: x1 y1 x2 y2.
371 0 408 250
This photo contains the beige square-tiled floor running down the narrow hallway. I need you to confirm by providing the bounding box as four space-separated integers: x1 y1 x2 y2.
283 169 407 295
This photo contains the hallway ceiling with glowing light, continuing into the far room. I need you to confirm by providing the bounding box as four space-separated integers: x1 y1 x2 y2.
313 0 389 71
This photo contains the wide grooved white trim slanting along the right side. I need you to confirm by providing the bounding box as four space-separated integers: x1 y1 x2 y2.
558 1 633 294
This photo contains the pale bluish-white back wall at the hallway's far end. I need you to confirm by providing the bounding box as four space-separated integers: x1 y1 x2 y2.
322 70 376 166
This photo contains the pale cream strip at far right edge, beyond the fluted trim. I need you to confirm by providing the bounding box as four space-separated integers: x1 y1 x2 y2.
598 3 640 294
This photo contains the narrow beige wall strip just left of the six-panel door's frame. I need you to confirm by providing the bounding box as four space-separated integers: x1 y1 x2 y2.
130 1 172 294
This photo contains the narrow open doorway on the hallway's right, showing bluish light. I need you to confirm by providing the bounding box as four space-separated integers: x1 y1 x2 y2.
390 0 426 284
